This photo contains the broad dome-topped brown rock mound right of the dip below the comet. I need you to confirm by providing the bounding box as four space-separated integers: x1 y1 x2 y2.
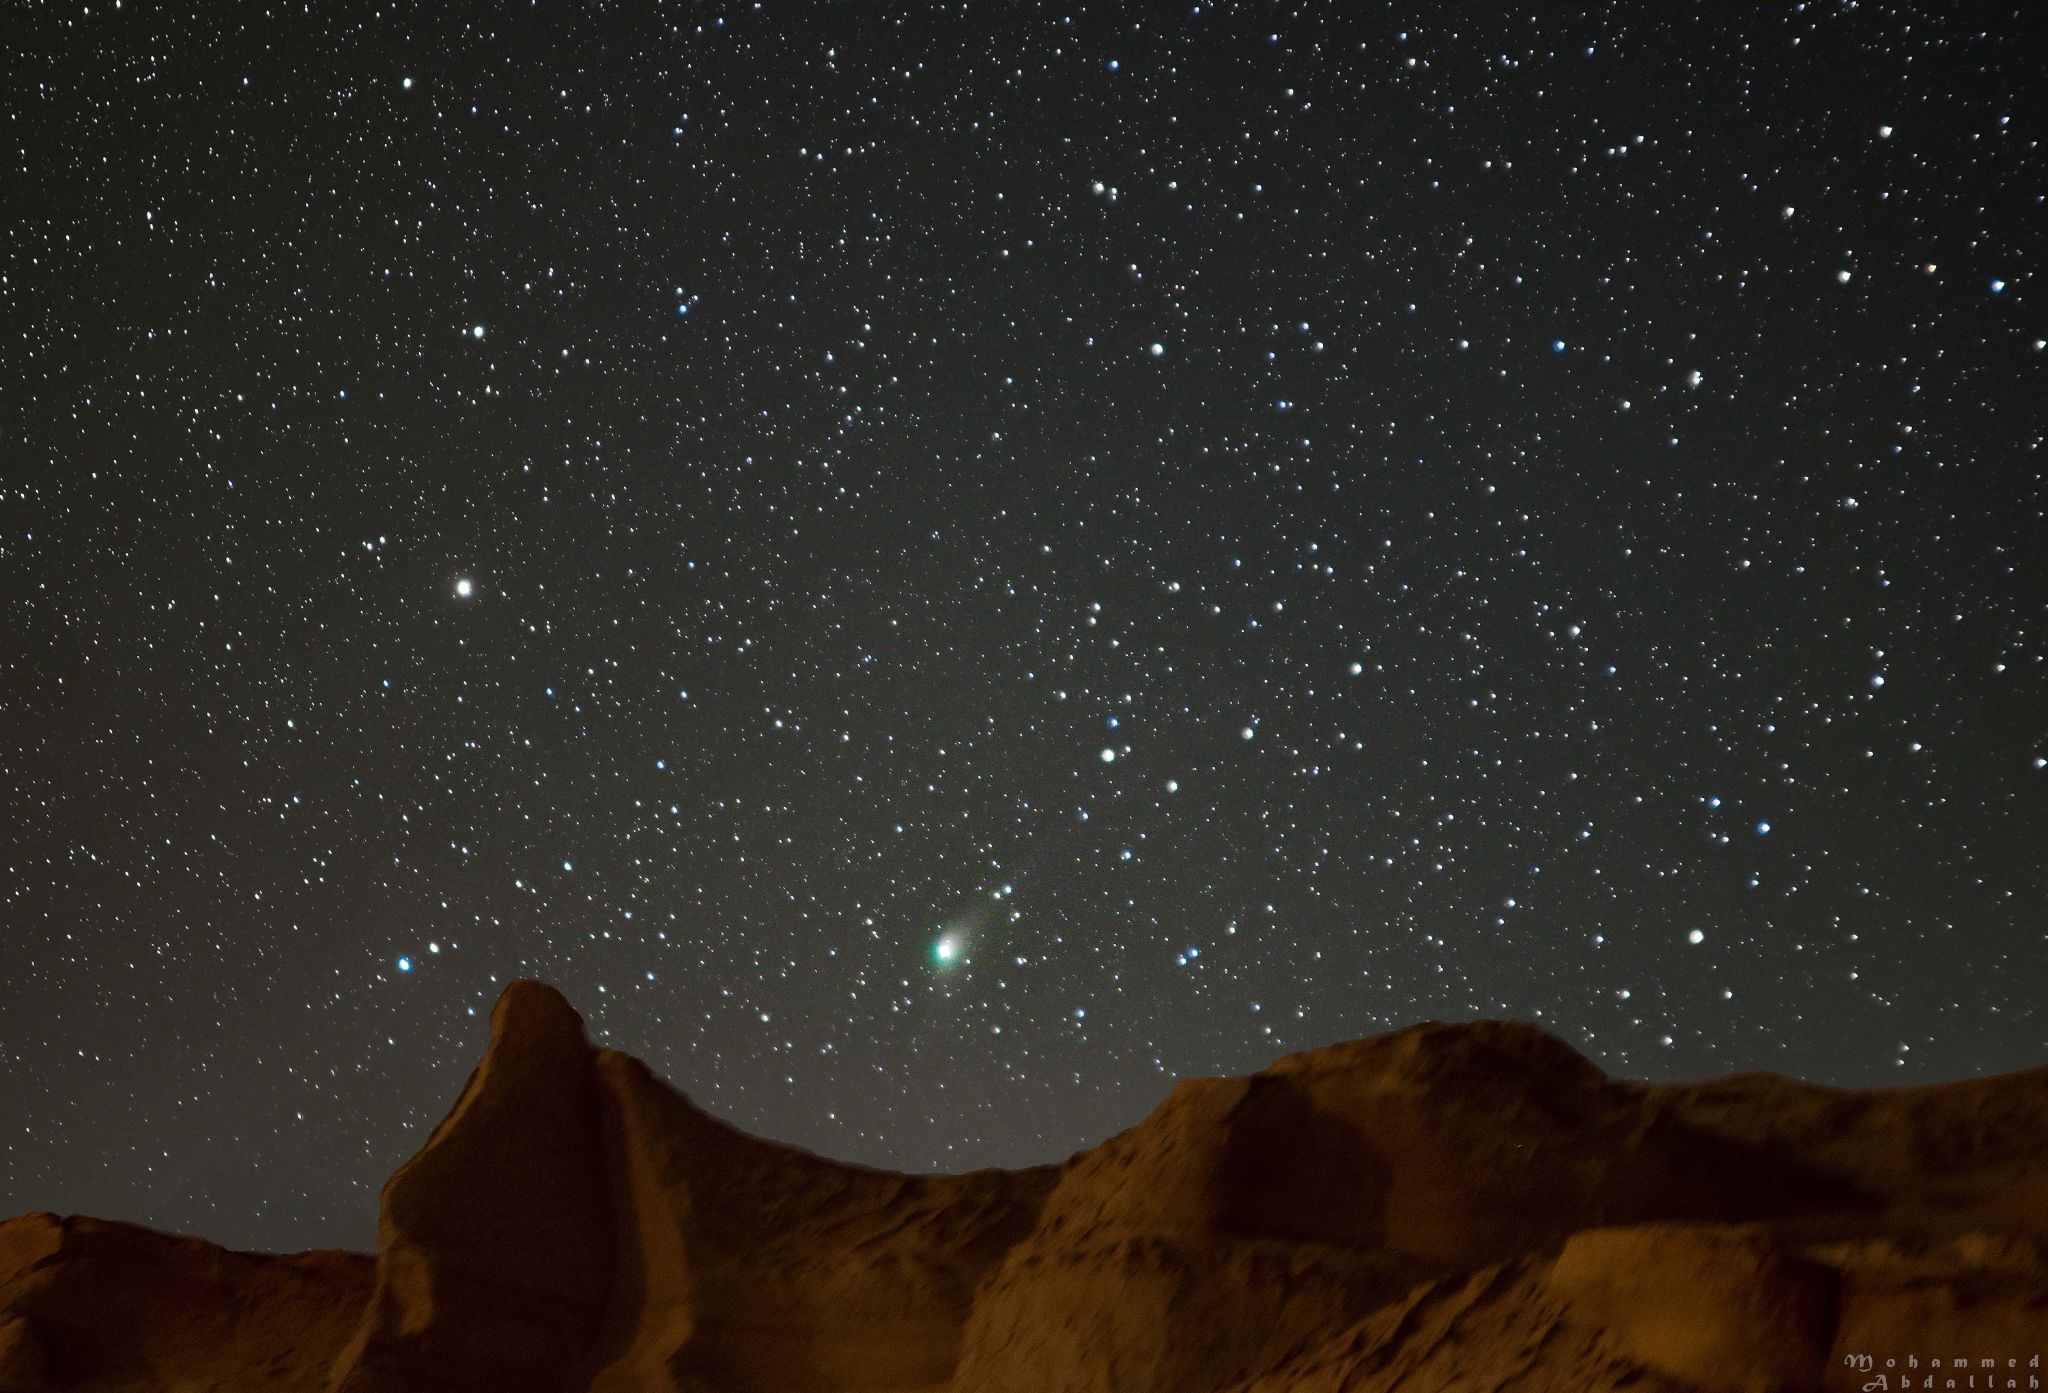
956 1022 1868 1393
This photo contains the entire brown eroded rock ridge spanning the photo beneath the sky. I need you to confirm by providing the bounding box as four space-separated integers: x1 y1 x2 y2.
0 983 2048 1393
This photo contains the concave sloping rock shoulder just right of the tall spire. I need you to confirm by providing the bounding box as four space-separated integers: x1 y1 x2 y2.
581 1055 1053 1391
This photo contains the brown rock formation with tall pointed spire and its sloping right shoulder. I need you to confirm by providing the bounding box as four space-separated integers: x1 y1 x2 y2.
332 983 1053 1393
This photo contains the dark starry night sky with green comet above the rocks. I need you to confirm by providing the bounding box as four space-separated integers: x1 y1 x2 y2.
0 0 2048 1248
